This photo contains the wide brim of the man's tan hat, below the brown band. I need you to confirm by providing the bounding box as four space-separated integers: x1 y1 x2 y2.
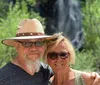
2 35 55 46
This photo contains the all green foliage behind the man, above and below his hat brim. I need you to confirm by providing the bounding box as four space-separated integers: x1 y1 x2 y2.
0 0 43 66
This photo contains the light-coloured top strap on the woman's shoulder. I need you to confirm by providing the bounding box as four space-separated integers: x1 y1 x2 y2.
75 71 85 85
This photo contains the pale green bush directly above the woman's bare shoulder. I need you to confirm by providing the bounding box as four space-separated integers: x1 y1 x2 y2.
72 51 96 72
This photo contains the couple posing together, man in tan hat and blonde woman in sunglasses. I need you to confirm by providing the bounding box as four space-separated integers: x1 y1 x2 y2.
0 19 100 85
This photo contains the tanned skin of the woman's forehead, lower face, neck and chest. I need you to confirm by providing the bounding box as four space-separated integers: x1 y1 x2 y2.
47 42 74 85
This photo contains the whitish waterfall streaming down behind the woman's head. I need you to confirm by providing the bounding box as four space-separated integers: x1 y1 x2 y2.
56 0 83 49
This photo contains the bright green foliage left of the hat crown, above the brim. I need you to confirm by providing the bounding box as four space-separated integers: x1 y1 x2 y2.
0 3 29 38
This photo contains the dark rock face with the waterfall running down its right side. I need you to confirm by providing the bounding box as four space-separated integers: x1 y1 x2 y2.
37 0 83 49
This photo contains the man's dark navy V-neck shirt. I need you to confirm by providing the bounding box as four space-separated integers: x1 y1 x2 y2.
0 62 52 85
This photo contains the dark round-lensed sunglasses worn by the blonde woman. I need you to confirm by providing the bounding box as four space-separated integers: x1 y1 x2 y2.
47 52 69 60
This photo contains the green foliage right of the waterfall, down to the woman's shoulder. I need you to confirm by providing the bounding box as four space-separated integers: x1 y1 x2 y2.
72 0 100 72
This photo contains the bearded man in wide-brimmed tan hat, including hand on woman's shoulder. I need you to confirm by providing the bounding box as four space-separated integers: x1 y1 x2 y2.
0 19 100 85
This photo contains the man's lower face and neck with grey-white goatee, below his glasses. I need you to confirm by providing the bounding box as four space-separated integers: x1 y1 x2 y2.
12 39 45 75
